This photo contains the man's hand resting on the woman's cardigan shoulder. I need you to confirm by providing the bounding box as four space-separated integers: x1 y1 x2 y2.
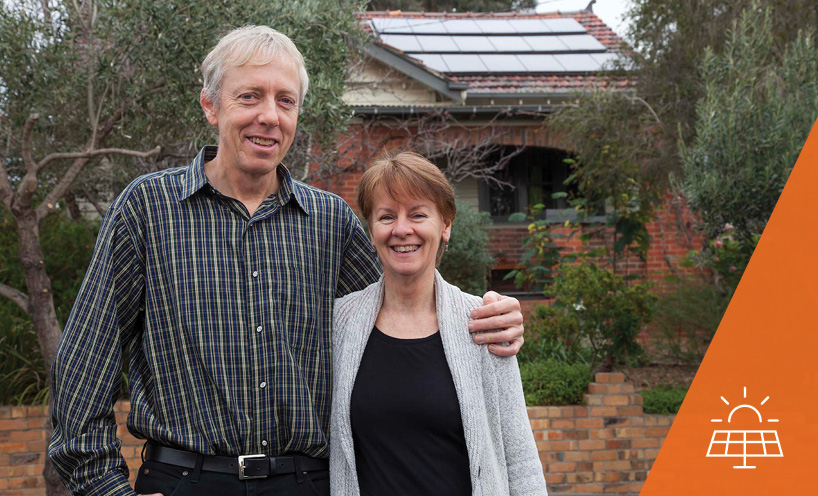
469 291 523 356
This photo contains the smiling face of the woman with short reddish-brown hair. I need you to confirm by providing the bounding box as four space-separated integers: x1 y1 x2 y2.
369 188 452 279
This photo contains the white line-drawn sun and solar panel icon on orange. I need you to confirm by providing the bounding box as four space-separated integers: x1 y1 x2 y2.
707 386 784 469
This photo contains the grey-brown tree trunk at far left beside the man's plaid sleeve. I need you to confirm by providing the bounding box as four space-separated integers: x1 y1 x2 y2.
14 208 71 496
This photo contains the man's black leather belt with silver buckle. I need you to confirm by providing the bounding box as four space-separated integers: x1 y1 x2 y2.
145 443 329 480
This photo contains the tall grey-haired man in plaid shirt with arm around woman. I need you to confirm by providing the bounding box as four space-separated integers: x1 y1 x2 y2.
49 27 522 496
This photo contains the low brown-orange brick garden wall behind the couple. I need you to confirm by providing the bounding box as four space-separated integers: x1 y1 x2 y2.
0 373 673 496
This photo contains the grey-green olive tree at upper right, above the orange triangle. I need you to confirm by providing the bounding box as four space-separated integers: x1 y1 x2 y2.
681 9 818 247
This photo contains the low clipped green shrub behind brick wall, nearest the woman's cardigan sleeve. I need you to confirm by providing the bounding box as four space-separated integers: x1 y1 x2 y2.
520 360 591 405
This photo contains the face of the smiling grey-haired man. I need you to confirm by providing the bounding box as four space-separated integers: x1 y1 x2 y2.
201 57 300 176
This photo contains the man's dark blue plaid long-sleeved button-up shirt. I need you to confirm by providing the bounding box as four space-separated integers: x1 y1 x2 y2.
49 147 379 495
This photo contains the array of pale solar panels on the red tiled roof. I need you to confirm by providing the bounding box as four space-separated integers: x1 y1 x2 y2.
372 18 617 74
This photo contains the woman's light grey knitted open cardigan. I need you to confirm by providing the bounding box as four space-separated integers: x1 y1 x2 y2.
330 271 546 496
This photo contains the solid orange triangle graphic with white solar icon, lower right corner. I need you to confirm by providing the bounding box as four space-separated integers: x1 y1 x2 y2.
640 116 818 496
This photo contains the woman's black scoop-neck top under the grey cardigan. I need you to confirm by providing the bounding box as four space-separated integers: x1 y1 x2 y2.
350 327 471 496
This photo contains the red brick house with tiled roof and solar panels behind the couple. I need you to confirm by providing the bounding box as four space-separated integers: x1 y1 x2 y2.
312 10 701 297
